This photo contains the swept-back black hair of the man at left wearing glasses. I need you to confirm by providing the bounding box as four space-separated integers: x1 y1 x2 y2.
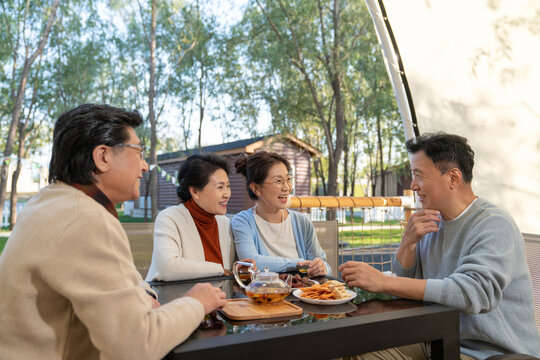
49 104 143 185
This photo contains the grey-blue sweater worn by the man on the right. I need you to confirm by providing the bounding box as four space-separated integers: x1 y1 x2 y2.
393 198 540 359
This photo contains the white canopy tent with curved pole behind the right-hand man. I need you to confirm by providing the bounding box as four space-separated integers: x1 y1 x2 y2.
366 0 540 234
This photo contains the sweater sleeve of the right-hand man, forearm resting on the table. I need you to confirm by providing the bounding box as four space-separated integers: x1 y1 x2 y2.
424 215 520 314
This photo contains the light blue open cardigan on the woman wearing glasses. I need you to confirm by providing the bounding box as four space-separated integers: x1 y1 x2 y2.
231 208 332 275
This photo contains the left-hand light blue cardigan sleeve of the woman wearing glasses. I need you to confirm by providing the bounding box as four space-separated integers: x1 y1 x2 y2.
231 210 303 272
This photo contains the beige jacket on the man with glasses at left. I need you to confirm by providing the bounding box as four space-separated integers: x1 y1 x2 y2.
0 183 204 360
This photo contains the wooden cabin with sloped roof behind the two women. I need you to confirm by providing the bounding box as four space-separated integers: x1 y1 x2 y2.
125 134 321 217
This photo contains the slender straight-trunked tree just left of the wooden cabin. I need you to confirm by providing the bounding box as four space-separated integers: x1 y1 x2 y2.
115 0 199 219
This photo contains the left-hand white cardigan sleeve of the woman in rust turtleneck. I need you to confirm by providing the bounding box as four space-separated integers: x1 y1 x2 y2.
147 211 224 281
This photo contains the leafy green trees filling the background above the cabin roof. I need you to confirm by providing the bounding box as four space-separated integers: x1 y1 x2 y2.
0 0 406 225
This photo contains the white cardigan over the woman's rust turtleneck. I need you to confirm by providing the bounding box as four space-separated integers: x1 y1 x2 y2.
146 204 235 281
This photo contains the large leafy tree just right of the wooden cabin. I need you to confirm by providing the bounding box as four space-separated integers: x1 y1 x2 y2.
229 0 395 195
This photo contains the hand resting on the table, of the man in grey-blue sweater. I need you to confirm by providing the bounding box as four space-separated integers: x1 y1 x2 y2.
339 261 388 292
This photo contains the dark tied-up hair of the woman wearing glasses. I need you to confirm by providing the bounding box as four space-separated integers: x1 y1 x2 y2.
234 151 291 200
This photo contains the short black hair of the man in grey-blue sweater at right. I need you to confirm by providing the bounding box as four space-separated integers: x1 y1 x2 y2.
406 132 474 184
